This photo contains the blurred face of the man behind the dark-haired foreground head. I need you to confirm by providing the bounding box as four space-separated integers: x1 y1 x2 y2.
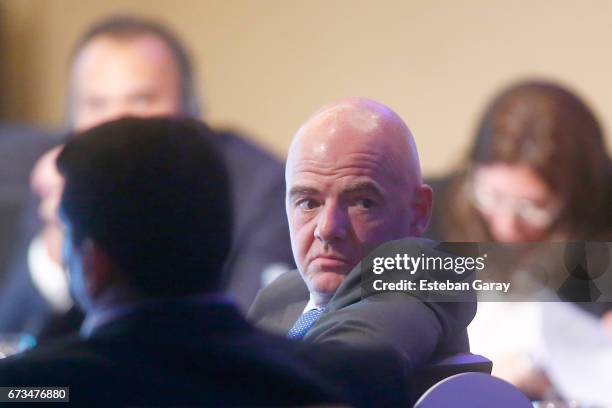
70 35 181 131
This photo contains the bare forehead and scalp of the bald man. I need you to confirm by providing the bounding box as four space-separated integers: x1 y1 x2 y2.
286 98 421 183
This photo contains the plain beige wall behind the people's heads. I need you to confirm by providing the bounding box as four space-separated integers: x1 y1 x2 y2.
0 0 612 175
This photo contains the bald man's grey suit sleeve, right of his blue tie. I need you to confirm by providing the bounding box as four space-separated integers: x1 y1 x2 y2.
304 239 476 368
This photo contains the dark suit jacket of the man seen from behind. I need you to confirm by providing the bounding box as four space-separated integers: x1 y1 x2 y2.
0 302 412 407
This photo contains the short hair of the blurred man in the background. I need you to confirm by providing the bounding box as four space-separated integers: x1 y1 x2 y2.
68 15 201 121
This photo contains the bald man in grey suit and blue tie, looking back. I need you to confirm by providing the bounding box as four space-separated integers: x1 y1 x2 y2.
249 99 476 369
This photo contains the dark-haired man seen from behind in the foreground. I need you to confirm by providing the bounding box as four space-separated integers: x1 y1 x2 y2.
0 118 408 407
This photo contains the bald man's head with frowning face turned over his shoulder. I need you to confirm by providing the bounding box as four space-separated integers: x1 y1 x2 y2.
286 99 431 296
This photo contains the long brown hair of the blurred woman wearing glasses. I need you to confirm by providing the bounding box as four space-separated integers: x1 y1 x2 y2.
446 81 612 240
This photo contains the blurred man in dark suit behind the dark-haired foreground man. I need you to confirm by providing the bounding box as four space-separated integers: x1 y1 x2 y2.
0 17 292 333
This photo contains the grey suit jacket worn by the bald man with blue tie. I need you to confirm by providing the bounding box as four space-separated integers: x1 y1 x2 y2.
249 238 476 370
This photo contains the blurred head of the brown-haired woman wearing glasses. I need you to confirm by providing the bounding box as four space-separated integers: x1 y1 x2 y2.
434 81 612 242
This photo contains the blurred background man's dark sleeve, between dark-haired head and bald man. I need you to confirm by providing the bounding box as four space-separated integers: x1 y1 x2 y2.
218 131 294 311
